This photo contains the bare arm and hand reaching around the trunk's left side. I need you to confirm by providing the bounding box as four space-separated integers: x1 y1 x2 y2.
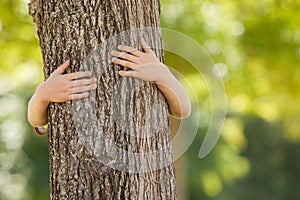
27 61 97 127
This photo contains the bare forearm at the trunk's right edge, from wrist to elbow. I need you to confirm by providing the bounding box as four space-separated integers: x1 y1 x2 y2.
156 69 191 118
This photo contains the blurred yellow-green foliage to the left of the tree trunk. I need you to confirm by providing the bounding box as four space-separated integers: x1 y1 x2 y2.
0 0 49 200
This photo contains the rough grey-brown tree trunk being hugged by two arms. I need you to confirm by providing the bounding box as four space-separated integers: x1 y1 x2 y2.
29 0 176 200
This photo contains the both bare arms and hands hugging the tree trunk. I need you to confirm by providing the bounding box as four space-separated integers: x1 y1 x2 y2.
28 39 191 127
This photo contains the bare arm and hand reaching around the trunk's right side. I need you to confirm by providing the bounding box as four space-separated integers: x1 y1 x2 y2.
110 39 191 118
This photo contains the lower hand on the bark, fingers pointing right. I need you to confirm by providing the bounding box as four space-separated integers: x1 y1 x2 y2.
36 60 97 102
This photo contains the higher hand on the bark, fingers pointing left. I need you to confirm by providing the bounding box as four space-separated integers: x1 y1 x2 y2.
110 38 170 83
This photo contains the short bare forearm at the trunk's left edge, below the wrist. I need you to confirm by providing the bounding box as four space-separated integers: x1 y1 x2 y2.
27 90 49 127
